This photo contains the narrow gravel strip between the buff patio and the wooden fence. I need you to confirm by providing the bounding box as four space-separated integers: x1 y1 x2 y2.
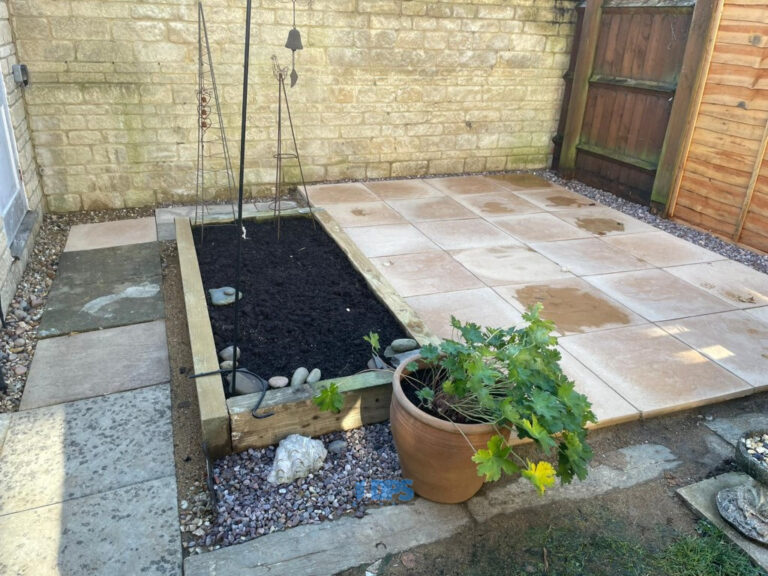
535 170 768 274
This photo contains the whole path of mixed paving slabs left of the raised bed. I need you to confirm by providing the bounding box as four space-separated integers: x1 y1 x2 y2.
0 219 182 576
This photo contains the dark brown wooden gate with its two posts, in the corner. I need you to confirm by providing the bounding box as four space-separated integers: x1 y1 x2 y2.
554 0 711 204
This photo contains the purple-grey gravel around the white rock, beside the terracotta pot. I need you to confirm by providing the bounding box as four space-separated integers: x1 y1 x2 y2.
181 422 401 553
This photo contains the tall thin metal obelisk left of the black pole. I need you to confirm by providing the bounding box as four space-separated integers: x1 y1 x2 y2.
195 1 235 244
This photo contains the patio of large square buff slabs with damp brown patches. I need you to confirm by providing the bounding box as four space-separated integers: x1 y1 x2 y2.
309 175 768 425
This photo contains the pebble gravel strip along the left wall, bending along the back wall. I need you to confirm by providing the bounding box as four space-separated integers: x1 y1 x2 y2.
0 208 154 413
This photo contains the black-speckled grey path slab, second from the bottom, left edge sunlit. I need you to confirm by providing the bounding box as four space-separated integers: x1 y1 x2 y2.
0 384 174 516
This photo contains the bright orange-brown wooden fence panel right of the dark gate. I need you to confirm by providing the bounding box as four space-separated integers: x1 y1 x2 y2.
669 0 768 251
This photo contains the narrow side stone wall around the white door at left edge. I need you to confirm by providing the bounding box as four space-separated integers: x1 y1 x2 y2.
0 0 42 314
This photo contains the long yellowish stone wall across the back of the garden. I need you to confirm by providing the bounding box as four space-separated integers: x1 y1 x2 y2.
10 0 576 211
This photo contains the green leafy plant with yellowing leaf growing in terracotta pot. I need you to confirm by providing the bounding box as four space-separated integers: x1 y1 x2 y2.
404 304 596 493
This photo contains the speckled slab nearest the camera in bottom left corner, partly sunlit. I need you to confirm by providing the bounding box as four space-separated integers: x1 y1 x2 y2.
0 475 182 576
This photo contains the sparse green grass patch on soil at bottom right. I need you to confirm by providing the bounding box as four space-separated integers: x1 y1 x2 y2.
420 516 768 576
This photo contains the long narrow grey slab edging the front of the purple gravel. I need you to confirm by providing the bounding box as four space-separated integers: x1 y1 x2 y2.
184 498 470 576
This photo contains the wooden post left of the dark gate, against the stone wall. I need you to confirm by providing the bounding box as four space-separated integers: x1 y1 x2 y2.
559 0 604 178
